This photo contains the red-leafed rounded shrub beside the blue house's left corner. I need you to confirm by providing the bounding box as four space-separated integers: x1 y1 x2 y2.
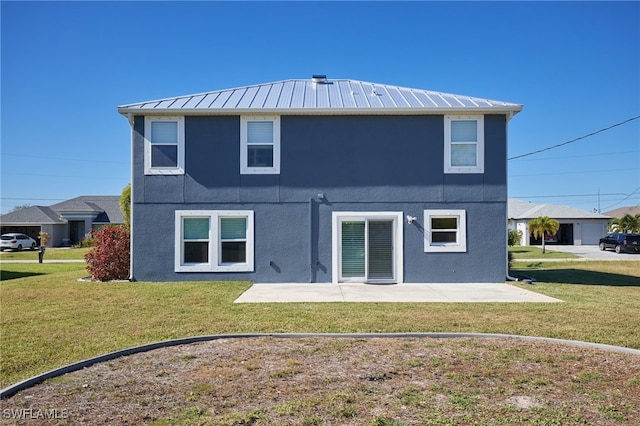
84 226 129 281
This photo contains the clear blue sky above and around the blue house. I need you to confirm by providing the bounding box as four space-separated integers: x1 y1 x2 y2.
0 1 640 213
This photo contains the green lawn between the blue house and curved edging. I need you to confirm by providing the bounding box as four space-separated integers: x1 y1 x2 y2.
0 258 640 387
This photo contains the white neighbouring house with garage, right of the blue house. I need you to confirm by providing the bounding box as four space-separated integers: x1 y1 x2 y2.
509 198 611 246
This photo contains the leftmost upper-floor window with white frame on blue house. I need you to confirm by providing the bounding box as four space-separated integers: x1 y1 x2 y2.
144 117 184 175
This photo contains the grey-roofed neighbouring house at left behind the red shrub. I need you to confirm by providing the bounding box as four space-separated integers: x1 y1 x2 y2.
0 195 124 247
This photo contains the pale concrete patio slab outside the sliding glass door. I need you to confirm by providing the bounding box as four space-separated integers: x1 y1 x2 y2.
234 283 561 303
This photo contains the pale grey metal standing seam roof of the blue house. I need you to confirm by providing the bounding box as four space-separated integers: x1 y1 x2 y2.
118 76 522 117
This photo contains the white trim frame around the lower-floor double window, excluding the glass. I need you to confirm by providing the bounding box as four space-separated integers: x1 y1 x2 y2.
175 210 255 272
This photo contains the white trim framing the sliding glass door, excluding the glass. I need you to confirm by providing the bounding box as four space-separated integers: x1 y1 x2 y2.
331 212 404 284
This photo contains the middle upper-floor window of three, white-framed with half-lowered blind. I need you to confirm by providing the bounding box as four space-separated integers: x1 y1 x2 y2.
240 116 280 174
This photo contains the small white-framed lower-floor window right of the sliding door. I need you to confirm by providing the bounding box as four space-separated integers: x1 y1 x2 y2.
424 210 467 252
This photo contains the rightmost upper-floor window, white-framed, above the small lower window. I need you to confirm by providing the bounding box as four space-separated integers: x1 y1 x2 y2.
444 115 484 173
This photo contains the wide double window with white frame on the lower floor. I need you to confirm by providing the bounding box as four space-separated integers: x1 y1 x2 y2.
175 210 254 272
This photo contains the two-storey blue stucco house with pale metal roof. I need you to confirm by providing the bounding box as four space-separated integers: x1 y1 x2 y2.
118 76 522 283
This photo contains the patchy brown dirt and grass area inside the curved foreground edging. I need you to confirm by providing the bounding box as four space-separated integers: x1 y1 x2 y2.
2 337 640 426
